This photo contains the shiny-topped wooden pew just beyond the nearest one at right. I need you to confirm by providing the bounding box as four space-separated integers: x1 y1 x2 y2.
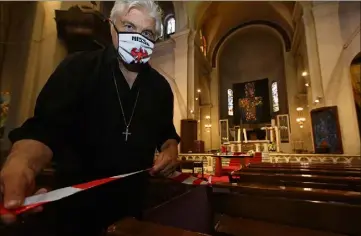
229 171 361 191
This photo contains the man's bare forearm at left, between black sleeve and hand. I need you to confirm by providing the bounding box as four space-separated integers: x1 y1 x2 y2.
5 139 53 174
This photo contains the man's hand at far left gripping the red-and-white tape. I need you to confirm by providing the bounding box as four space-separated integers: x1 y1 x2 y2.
0 157 46 224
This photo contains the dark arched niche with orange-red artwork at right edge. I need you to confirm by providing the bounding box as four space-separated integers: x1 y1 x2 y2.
350 52 361 139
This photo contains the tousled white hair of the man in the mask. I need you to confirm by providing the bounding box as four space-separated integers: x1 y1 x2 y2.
110 0 162 37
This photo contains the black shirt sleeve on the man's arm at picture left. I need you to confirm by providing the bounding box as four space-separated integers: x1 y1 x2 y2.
9 55 83 152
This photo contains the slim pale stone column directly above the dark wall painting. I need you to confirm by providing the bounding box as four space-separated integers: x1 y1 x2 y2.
302 5 324 105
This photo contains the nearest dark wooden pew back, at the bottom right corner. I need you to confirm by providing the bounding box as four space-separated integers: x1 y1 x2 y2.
212 192 361 236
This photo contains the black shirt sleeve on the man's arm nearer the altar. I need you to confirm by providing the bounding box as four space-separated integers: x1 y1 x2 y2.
157 84 180 151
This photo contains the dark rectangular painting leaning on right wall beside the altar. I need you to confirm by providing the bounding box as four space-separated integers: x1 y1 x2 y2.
311 106 343 154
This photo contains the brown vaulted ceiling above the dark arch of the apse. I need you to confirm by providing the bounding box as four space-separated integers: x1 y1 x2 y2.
187 1 295 65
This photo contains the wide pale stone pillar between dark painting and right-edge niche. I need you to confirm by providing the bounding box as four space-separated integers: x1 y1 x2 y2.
311 2 360 155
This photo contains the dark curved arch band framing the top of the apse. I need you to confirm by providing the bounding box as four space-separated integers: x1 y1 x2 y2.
212 20 292 67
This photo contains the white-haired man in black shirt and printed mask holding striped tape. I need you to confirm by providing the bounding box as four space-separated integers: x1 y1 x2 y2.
0 0 179 236
